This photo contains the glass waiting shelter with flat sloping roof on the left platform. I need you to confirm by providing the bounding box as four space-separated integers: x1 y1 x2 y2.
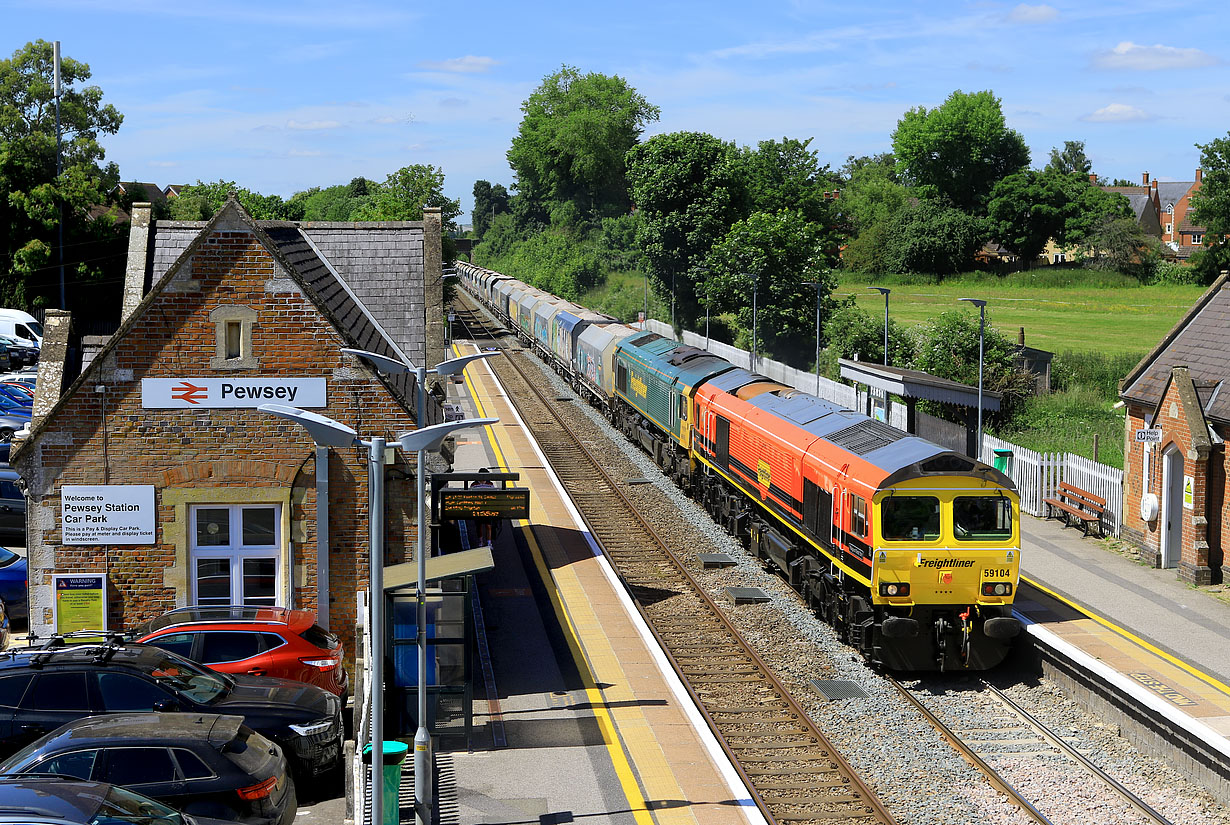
384 547 496 743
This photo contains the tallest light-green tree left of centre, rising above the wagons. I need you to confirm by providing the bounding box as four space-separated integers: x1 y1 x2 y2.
508 65 659 220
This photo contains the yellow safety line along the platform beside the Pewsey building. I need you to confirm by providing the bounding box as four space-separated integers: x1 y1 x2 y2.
453 344 654 825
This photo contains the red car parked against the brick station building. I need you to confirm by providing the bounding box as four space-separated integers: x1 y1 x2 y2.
132 605 351 701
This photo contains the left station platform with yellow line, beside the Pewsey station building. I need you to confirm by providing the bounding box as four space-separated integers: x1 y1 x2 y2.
437 345 764 825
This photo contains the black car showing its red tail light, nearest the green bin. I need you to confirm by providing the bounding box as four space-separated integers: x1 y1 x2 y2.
0 713 298 825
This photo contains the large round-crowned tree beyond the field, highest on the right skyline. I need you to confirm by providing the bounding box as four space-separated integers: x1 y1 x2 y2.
893 90 1030 214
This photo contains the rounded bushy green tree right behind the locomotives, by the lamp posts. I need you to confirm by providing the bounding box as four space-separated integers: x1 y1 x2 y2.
706 209 836 365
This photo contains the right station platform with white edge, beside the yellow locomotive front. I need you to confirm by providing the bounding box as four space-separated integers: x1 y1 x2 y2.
1015 516 1230 799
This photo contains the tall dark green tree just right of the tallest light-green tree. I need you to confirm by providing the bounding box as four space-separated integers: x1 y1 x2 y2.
627 132 748 323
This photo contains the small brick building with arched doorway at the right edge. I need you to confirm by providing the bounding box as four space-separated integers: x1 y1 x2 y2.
1119 273 1230 584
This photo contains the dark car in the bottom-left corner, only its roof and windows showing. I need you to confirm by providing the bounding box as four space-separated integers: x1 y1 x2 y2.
0 776 225 825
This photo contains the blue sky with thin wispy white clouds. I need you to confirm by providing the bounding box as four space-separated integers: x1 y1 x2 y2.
9 0 1230 223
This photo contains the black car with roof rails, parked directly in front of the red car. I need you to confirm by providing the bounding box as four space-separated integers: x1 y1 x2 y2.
0 637 342 777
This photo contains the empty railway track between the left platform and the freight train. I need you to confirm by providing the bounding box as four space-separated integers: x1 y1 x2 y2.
458 296 895 825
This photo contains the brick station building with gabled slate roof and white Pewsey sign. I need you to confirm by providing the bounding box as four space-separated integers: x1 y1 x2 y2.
12 198 444 654
